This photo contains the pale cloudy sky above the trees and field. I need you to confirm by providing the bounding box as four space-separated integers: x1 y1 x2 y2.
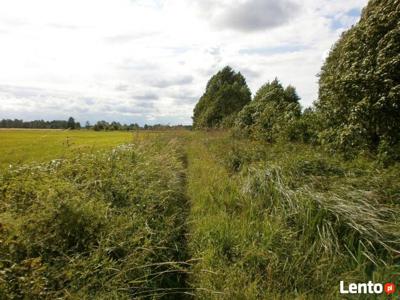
0 0 367 124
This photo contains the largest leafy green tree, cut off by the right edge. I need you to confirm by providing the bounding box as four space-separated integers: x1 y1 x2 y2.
316 0 400 159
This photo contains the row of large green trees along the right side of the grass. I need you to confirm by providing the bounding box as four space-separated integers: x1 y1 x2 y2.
193 0 400 162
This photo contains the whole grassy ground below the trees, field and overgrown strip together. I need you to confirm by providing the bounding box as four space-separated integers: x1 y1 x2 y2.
0 131 400 299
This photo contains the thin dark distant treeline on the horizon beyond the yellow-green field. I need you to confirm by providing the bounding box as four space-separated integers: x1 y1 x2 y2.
0 117 192 131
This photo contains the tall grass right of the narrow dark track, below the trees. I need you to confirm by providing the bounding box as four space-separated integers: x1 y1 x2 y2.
189 136 400 299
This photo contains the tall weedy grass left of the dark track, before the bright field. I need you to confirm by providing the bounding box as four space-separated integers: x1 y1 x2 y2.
0 137 188 299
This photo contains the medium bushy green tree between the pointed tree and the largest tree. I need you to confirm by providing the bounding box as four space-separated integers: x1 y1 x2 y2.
235 79 301 142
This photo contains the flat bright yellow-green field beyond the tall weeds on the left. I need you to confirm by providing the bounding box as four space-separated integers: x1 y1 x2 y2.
0 130 137 169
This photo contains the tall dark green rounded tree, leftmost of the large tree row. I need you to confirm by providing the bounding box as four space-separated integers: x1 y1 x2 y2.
193 67 251 129
